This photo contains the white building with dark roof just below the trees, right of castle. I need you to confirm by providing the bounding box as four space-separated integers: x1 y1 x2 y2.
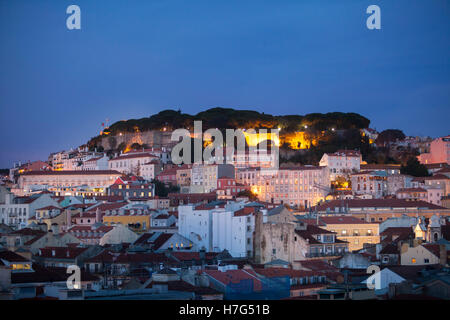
319 150 362 181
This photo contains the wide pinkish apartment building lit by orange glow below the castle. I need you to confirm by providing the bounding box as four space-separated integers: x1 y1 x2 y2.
237 166 330 207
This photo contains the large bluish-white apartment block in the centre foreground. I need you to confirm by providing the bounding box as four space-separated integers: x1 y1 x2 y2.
178 202 255 257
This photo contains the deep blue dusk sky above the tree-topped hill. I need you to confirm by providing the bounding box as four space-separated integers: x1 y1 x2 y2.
0 0 450 167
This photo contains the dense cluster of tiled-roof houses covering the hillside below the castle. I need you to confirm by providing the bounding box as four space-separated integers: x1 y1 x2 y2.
0 132 450 300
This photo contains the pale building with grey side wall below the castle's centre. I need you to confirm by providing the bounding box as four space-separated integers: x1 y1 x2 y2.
190 164 235 193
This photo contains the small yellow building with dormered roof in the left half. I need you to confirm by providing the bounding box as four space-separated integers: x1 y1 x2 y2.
103 209 151 232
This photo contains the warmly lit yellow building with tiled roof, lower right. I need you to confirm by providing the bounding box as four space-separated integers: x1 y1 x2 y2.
320 216 380 251
